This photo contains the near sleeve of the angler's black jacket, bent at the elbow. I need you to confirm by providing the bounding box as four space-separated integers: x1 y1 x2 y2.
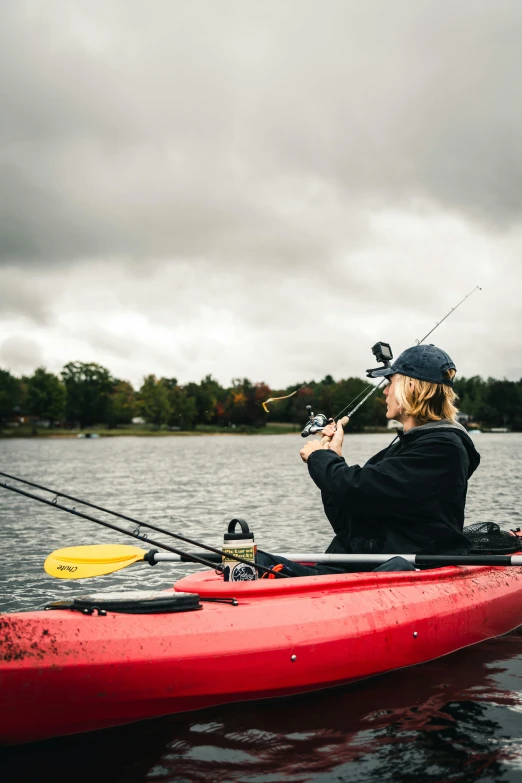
307 438 463 513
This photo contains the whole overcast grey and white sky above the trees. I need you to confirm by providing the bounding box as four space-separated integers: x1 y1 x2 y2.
0 0 522 388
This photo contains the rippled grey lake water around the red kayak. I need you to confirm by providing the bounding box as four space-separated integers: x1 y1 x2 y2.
0 434 522 783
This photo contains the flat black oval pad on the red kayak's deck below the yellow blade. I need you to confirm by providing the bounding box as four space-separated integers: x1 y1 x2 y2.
45 590 203 614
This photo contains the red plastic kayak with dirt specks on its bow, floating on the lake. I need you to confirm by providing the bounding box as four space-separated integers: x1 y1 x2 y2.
0 566 522 744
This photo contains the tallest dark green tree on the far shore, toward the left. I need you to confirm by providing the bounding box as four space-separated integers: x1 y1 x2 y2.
62 362 114 429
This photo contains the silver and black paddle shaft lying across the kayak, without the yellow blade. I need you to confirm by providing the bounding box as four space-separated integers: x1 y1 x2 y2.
152 552 522 566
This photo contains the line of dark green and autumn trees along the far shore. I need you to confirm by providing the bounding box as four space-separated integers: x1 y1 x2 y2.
0 362 522 431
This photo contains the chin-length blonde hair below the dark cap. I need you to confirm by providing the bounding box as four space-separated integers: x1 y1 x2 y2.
394 369 459 425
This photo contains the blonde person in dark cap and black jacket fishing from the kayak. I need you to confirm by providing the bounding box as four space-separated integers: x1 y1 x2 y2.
256 345 480 575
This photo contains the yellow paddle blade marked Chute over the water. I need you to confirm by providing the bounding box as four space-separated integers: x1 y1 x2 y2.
44 544 146 579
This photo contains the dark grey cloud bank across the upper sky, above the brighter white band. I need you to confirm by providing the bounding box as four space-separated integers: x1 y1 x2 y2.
0 0 522 263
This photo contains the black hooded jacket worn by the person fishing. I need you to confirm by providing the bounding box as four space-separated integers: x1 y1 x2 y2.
308 421 480 554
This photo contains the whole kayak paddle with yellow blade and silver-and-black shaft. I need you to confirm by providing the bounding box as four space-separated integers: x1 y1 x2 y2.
44 544 522 579
